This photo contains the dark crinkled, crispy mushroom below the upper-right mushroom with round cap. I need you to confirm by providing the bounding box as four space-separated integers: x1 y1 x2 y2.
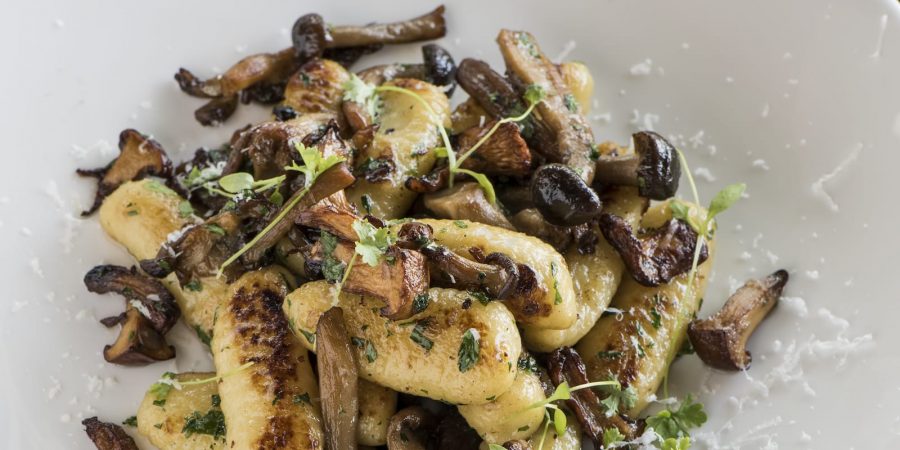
600 214 709 286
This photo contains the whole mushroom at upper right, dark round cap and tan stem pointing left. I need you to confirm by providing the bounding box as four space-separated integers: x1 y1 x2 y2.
596 131 681 200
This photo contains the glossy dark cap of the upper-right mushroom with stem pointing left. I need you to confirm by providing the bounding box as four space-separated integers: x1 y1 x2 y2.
631 131 681 200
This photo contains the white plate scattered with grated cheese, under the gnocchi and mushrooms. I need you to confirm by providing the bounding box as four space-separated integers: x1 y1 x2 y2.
0 0 900 449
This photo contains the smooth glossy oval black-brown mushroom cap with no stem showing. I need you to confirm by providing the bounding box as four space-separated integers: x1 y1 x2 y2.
531 164 603 226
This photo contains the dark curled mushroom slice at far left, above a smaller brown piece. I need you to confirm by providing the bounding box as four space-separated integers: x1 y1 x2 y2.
84 265 181 334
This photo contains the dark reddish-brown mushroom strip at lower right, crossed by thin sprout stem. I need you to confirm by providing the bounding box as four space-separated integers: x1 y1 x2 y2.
547 347 638 448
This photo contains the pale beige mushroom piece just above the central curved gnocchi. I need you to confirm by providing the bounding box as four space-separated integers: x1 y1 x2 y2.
422 183 513 230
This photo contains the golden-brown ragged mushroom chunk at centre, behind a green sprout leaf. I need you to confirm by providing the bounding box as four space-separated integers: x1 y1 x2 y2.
310 232 428 320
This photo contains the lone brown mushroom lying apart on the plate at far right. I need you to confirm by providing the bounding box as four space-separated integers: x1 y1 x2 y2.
688 270 788 370
